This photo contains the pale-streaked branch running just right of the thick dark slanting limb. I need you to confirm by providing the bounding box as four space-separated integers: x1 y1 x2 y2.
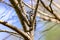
17 0 30 32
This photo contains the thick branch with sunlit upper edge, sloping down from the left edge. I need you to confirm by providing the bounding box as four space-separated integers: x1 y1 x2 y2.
0 20 30 39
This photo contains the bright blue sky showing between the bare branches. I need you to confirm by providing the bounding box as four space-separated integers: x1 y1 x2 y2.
0 0 44 40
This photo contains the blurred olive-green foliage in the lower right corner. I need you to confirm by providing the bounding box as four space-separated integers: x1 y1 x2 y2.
46 23 60 40
